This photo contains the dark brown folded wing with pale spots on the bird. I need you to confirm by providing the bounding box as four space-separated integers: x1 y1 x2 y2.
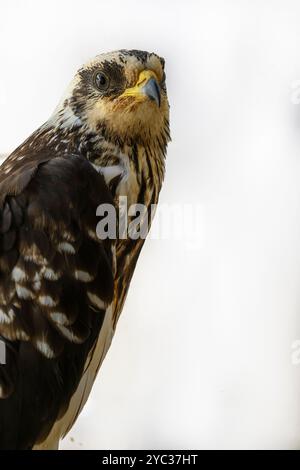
0 155 114 449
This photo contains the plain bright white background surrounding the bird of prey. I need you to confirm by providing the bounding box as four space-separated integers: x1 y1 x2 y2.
0 0 300 449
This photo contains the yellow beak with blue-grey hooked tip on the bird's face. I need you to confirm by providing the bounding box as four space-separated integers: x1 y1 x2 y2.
121 70 161 107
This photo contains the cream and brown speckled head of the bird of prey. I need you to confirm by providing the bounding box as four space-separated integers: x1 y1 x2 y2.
56 50 169 144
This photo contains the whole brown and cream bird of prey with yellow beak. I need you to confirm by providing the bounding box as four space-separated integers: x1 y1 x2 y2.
0 50 170 449
